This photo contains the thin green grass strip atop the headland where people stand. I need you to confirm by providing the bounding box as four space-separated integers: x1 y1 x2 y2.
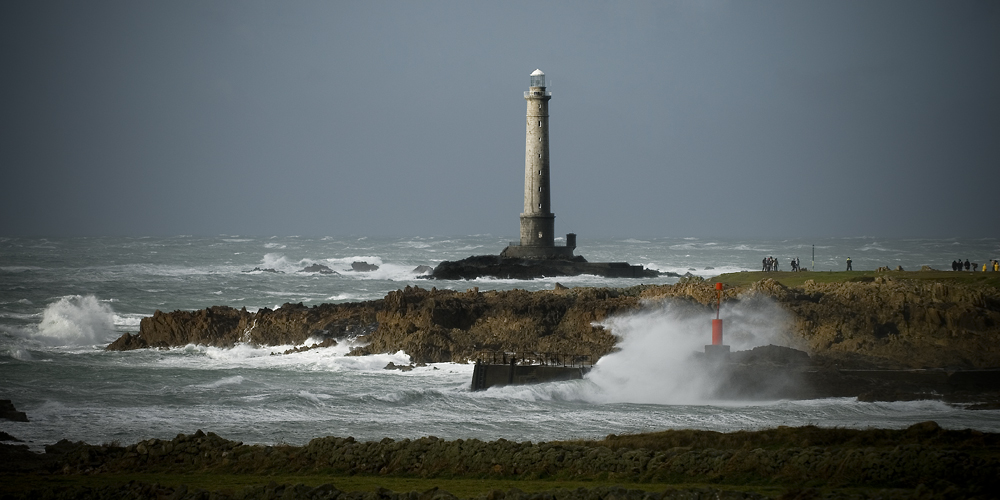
708 271 1000 287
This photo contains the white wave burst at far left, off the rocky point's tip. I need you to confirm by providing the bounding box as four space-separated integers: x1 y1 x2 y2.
32 295 114 345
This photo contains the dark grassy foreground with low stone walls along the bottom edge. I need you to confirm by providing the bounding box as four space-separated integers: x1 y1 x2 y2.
0 422 1000 499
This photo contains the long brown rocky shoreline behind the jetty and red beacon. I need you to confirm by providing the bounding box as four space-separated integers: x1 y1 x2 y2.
107 277 1000 402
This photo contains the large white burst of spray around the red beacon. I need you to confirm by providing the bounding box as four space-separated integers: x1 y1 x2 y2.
585 295 792 404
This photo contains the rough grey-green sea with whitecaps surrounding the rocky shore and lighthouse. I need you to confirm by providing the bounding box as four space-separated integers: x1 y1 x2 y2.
0 234 1000 450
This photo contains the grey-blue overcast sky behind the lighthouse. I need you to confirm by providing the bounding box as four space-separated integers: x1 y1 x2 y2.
0 0 1000 239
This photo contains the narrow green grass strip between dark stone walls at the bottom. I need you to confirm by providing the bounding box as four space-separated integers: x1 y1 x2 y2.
0 473 787 498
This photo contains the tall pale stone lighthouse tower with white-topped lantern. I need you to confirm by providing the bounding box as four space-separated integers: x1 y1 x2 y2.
501 69 576 259
